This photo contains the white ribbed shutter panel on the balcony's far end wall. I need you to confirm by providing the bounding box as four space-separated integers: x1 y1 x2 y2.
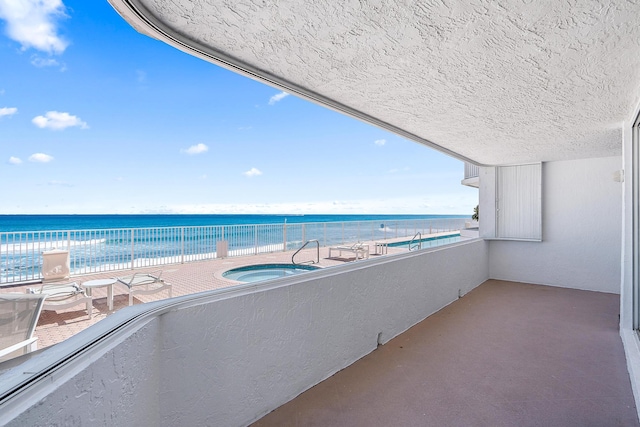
496 163 542 240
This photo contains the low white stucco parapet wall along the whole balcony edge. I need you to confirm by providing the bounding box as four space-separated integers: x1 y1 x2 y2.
0 240 489 426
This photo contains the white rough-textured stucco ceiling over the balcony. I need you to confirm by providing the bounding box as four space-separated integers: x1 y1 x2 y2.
110 0 640 165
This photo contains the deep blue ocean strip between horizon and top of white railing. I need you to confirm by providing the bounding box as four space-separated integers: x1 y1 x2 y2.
0 214 471 233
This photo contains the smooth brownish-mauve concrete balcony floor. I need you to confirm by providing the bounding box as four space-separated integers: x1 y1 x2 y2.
254 280 639 427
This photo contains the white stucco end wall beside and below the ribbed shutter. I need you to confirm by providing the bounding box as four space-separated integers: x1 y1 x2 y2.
488 156 623 293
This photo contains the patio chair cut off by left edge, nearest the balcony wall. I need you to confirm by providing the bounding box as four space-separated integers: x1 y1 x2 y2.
0 293 46 362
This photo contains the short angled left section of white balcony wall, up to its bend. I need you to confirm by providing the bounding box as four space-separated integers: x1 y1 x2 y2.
0 318 161 427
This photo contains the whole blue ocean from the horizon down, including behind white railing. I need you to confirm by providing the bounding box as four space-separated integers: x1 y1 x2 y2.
0 215 470 286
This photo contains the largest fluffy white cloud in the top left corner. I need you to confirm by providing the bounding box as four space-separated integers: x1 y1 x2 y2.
0 0 69 54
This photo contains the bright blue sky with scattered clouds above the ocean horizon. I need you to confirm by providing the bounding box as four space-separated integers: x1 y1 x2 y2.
0 0 478 214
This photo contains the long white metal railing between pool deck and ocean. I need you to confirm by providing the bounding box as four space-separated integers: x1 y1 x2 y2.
0 218 468 285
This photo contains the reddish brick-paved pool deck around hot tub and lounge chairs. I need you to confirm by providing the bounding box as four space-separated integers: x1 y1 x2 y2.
0 232 457 349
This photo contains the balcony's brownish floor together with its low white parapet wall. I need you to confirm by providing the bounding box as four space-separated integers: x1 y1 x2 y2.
0 240 637 426
